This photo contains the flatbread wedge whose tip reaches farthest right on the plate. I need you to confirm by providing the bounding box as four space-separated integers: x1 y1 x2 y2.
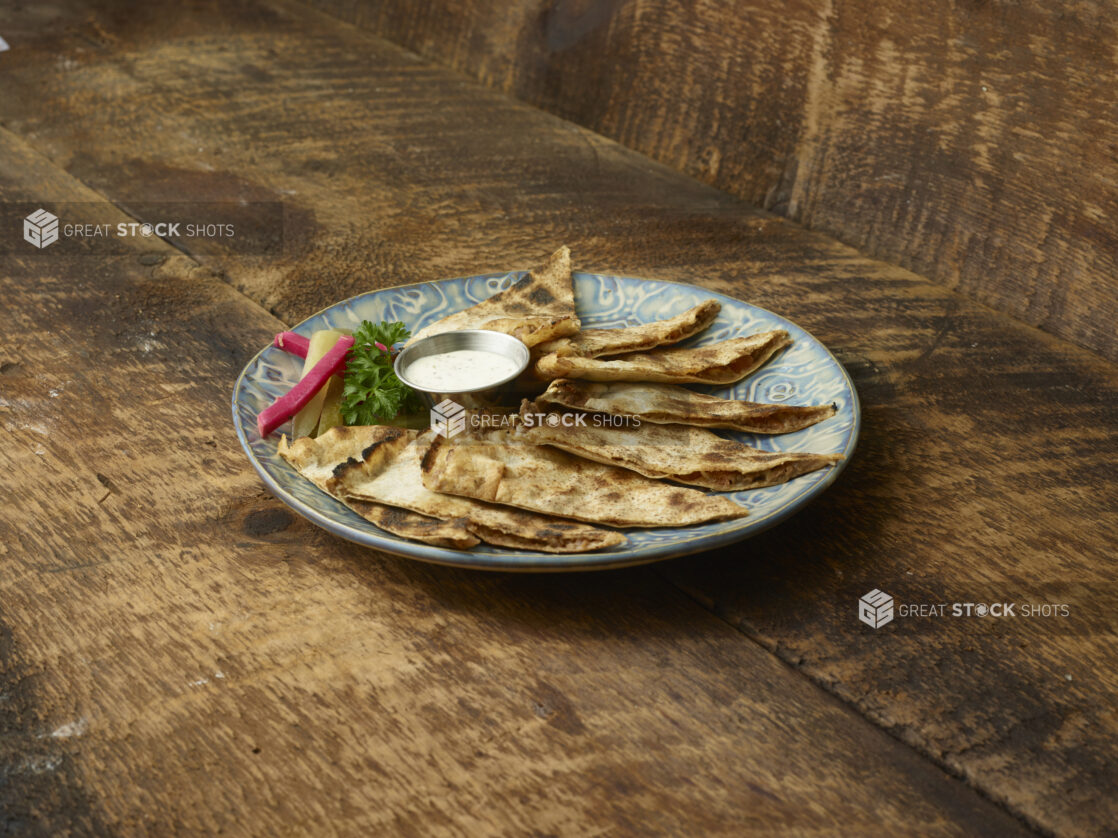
513 402 842 492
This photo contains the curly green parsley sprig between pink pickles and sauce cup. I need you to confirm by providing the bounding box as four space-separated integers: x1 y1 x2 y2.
341 321 423 425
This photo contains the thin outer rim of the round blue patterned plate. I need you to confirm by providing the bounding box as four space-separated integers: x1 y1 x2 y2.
233 270 862 572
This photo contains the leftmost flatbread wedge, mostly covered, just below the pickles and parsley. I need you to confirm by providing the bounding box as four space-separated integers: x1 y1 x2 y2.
280 425 479 550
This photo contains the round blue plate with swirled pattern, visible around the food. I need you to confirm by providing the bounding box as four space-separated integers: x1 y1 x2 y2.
233 272 860 571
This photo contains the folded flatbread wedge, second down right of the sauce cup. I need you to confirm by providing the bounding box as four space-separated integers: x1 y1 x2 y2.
534 328 792 384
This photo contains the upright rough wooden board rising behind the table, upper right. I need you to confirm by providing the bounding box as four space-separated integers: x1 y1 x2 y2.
297 0 1118 360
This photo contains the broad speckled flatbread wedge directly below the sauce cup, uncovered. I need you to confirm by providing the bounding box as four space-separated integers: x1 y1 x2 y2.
423 431 748 526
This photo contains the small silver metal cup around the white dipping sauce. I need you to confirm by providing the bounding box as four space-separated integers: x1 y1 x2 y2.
394 328 531 408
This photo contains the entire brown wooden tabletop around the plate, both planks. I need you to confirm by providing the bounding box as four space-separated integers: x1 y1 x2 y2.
0 0 1118 836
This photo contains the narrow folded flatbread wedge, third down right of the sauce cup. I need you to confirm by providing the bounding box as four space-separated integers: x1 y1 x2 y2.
536 379 835 434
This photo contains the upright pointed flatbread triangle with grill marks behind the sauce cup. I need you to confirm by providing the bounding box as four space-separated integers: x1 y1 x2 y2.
411 246 579 346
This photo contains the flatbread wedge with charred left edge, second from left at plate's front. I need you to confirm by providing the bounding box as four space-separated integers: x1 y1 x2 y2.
328 431 625 553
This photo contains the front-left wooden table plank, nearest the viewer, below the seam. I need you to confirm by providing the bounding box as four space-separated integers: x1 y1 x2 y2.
0 131 1026 836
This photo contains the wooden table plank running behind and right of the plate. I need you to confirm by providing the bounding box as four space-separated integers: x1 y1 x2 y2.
0 3 1118 832
